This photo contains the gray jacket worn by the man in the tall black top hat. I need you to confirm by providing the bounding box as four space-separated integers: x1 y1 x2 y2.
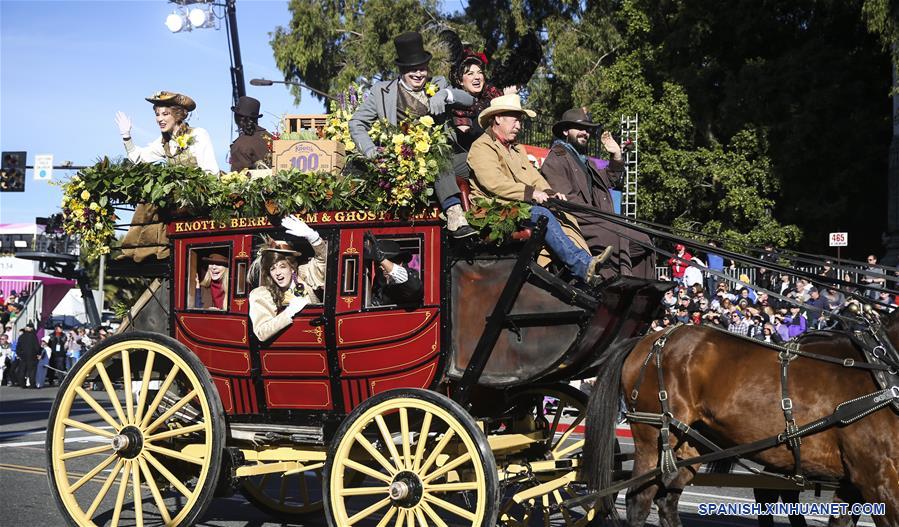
349 77 474 154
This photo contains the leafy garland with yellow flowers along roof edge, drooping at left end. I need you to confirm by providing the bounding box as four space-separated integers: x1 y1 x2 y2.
62 158 368 259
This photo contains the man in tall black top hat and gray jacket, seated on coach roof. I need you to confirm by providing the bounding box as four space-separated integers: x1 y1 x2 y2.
349 32 476 238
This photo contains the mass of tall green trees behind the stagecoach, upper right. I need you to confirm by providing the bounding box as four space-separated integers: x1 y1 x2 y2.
272 0 899 251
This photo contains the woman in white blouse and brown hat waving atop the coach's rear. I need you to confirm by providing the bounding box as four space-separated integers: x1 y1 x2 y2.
115 91 219 262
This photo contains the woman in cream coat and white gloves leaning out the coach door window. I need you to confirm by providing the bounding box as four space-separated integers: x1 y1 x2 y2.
250 216 328 342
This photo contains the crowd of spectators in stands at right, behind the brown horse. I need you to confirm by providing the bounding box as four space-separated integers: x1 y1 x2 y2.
652 248 899 344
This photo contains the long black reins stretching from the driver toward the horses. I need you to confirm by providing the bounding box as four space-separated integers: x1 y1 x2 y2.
549 199 885 325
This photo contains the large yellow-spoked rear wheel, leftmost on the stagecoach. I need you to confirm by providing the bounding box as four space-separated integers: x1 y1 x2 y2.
47 332 225 527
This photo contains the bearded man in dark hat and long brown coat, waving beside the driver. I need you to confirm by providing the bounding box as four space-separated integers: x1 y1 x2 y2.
540 108 655 278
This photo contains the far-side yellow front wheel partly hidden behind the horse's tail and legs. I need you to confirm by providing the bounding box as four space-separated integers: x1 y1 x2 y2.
499 383 620 527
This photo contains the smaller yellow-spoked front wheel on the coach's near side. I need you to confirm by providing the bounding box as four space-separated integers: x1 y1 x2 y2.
324 389 499 527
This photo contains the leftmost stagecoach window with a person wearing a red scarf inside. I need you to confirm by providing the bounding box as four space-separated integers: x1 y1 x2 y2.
184 245 230 310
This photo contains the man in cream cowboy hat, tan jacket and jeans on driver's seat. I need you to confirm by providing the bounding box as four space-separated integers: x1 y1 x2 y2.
468 94 611 284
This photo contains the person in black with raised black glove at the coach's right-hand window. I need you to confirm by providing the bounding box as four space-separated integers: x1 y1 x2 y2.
365 231 421 306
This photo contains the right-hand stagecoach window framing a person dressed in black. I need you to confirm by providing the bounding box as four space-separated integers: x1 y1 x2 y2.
363 236 425 308
